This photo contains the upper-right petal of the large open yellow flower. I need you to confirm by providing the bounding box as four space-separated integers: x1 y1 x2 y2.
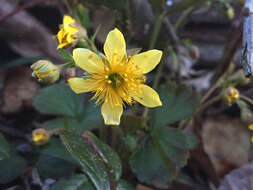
132 50 163 74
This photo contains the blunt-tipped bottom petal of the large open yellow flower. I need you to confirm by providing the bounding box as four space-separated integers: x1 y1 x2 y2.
101 102 123 125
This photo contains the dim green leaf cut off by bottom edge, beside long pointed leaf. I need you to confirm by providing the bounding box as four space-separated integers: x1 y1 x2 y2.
50 174 95 190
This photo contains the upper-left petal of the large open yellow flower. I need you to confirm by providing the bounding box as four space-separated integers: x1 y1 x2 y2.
73 48 103 73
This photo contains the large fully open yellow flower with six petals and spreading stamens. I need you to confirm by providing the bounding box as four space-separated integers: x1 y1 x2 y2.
68 29 162 125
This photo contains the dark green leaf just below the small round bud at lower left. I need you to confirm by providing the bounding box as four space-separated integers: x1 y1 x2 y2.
36 154 74 179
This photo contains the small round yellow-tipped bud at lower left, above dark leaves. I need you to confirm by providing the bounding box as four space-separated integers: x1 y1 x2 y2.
32 128 50 145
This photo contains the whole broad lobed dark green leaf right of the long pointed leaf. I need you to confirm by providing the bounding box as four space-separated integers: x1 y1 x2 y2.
130 126 197 184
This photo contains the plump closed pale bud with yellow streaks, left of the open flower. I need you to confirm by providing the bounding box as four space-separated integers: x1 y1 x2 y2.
31 60 61 83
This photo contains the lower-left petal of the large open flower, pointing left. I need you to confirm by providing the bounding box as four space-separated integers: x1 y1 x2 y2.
68 78 90 94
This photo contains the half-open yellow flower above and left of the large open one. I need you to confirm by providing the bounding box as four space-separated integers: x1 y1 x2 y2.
57 15 87 49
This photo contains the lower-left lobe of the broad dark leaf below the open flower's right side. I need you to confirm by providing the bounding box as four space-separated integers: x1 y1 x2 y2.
130 139 175 184
